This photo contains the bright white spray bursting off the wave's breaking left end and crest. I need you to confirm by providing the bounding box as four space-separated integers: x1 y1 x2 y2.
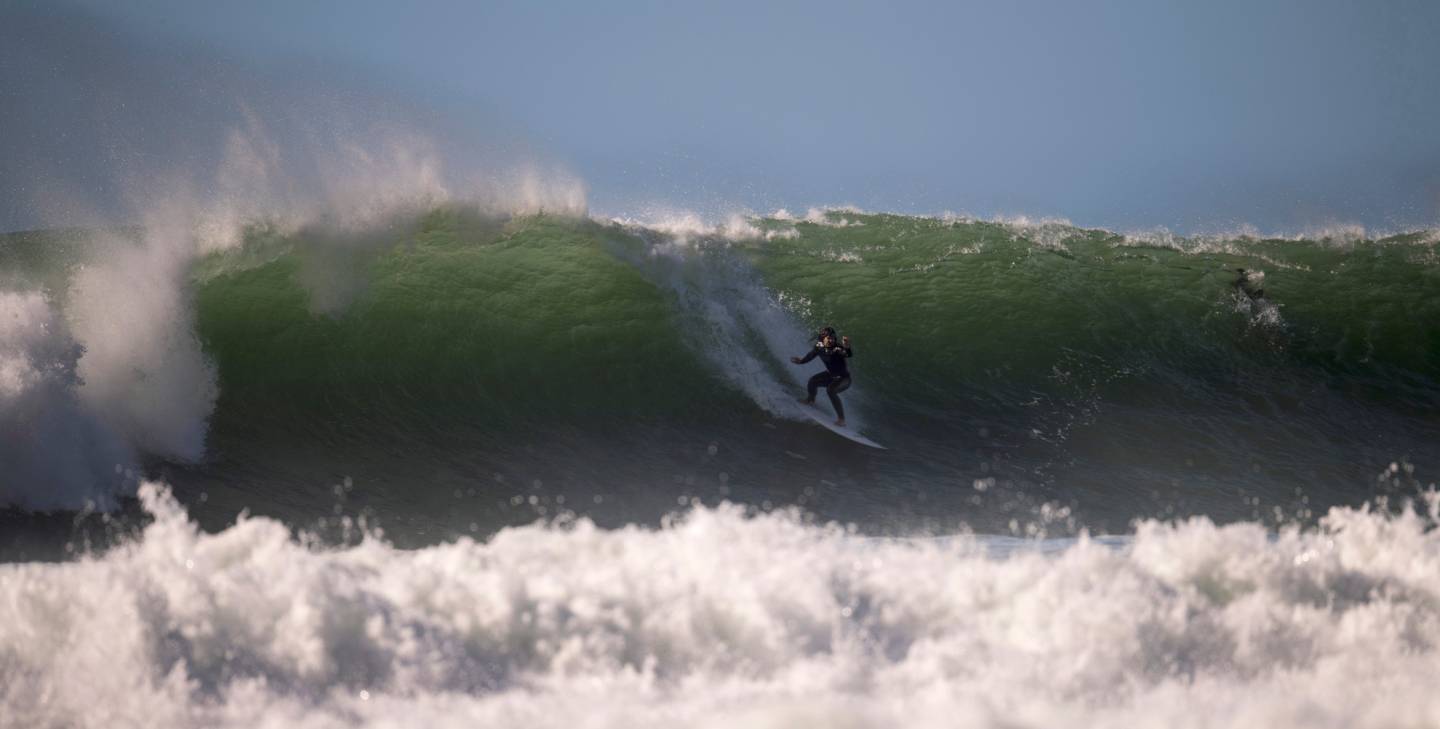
0 114 585 509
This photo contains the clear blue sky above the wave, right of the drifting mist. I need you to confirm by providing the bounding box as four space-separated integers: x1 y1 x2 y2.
8 0 1440 231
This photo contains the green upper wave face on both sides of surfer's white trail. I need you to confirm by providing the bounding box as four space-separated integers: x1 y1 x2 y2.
196 209 1440 418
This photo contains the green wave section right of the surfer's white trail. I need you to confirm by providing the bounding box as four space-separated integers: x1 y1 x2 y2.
753 213 1440 412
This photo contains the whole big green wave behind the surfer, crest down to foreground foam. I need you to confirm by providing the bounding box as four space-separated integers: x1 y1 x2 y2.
4 205 1440 546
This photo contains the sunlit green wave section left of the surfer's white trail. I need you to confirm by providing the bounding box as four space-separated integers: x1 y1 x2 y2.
196 210 720 419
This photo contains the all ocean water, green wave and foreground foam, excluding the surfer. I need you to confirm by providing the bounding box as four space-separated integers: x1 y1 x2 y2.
0 196 1440 728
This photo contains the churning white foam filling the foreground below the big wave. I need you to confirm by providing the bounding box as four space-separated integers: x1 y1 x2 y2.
0 486 1440 728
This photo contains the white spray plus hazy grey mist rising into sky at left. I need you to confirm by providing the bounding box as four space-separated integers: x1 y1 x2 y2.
0 2 586 510
